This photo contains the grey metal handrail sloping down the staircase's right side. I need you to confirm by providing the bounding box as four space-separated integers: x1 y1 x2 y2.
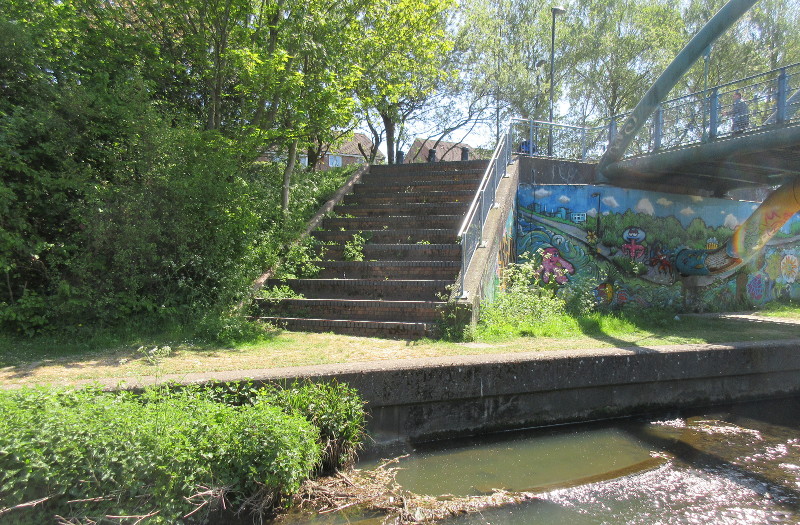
458 130 512 299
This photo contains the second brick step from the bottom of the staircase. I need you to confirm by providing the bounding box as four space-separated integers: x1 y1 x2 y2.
254 299 447 323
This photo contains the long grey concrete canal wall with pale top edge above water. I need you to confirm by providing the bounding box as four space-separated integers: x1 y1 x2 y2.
98 339 800 445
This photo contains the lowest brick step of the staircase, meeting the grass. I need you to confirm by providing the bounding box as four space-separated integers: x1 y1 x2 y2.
255 316 436 339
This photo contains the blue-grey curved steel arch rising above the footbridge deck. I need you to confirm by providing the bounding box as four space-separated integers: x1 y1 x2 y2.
597 0 758 177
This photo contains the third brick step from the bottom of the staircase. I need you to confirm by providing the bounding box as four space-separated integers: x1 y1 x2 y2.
265 279 453 301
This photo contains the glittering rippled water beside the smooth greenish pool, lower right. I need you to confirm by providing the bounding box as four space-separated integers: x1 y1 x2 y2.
452 398 800 525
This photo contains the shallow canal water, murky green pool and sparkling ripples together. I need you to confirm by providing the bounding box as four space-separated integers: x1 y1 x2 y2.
361 397 800 525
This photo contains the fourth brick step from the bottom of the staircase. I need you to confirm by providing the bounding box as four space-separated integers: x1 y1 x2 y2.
316 261 461 280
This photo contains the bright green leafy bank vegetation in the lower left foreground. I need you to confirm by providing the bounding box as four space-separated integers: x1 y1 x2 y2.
0 383 364 524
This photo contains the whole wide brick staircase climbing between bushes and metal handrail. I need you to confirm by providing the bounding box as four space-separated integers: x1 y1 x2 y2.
256 161 487 338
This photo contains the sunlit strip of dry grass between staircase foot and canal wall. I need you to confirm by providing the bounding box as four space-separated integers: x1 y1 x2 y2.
0 300 800 386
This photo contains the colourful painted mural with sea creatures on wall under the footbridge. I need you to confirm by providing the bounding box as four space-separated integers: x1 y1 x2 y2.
516 184 800 310
